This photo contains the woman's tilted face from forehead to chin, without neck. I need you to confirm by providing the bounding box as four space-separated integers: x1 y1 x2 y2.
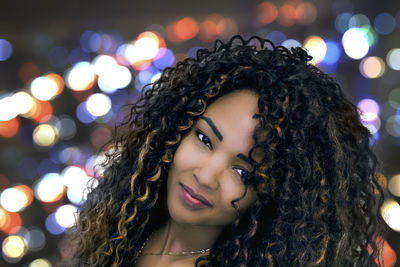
167 90 258 226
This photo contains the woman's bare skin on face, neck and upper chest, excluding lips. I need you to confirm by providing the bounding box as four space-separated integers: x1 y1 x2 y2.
137 90 258 266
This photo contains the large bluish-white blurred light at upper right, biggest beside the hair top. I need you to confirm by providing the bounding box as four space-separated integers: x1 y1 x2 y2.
342 28 369 59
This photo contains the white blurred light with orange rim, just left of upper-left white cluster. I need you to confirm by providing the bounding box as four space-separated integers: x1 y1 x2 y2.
64 62 96 91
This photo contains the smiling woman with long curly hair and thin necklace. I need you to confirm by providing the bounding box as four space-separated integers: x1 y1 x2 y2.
65 36 382 266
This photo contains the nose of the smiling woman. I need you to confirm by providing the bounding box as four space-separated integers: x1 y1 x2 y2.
193 159 225 190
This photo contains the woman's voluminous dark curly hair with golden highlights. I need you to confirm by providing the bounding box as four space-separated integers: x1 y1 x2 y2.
65 36 383 266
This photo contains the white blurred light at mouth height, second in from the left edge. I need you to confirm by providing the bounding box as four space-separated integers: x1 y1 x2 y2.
34 173 65 202
